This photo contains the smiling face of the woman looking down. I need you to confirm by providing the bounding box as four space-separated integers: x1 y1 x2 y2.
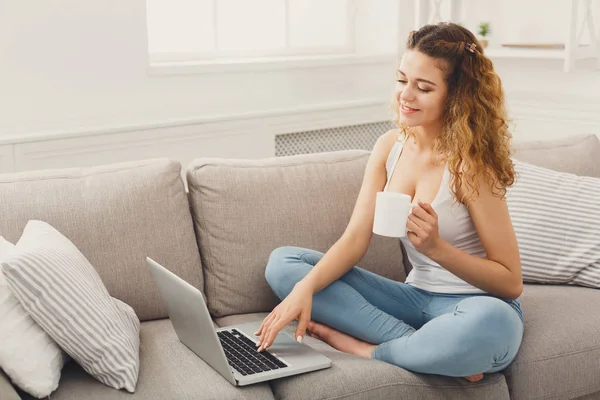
396 50 448 127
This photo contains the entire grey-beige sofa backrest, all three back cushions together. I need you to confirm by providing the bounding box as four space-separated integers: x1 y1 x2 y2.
0 135 600 321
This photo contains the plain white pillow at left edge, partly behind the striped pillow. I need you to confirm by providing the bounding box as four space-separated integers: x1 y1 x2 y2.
0 236 68 398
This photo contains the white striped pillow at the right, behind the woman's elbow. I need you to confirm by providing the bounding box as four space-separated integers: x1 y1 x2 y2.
507 160 600 288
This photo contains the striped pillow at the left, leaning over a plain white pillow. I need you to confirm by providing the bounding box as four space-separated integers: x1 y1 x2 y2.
2 221 140 393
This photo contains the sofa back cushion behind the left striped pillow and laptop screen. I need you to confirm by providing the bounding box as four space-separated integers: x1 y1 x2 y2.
0 159 203 320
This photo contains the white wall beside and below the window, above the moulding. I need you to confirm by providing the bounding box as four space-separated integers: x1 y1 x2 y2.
0 0 390 135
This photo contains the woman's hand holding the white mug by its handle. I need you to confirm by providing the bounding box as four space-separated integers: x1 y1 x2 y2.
406 201 440 258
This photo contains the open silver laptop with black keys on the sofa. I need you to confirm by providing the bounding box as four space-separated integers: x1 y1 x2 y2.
146 257 331 386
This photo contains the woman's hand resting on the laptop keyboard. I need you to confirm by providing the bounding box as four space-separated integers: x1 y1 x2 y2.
255 282 314 352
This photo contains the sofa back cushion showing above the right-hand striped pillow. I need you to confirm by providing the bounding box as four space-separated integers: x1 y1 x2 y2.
513 135 600 178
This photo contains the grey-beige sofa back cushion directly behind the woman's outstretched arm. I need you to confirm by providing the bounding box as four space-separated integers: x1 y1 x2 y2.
187 150 405 317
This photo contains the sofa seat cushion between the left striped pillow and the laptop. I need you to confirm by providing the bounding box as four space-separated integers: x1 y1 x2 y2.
42 319 273 400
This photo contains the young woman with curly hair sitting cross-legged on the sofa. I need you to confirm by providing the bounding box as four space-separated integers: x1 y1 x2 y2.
256 23 523 382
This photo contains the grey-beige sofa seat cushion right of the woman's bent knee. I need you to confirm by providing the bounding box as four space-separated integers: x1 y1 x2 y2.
503 284 600 400
